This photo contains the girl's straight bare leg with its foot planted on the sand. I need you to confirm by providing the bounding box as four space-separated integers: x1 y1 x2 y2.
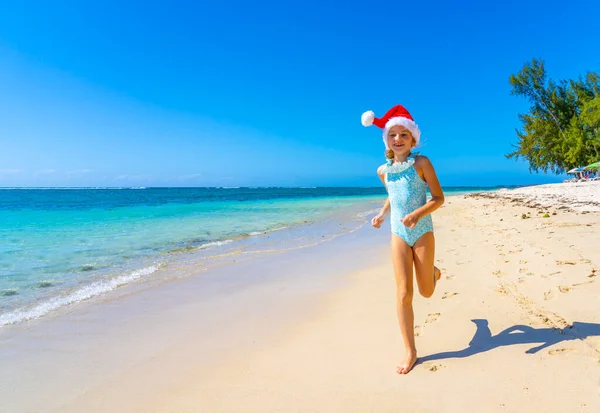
391 234 417 374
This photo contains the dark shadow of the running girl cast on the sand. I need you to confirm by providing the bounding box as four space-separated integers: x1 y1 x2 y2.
417 319 600 364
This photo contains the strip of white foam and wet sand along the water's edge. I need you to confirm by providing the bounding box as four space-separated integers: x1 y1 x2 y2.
0 198 382 330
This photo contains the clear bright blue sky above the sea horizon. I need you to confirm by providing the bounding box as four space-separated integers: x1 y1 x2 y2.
0 0 600 186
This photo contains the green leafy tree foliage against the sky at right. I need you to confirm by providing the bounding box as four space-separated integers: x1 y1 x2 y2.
506 59 600 173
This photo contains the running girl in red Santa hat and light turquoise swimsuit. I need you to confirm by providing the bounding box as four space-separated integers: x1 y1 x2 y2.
362 105 444 374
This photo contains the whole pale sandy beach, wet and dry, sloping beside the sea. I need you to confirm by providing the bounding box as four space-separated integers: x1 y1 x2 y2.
0 182 600 412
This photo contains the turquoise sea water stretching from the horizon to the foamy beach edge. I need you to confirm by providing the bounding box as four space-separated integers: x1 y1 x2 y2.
0 188 494 326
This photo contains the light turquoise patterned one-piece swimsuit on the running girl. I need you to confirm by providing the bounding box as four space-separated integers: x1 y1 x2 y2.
385 155 433 247
